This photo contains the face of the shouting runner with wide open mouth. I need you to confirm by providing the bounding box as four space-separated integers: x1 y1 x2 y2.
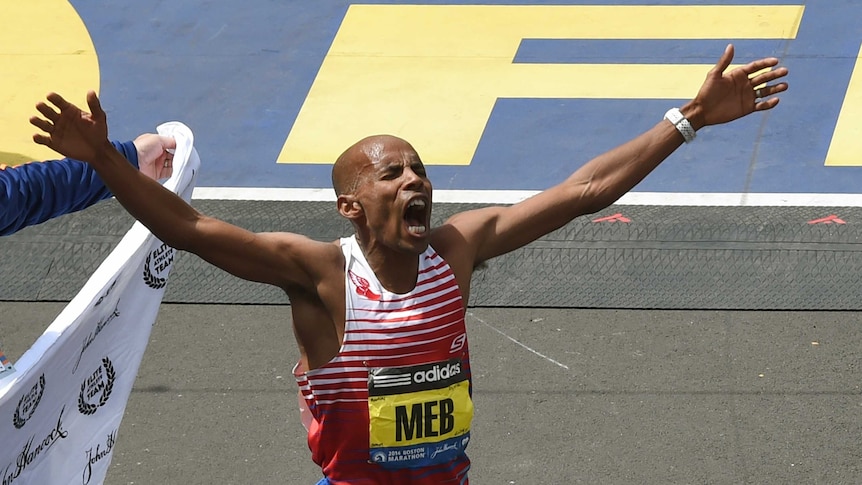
356 139 431 253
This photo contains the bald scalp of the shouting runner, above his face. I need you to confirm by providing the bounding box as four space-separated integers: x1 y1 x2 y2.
332 135 415 195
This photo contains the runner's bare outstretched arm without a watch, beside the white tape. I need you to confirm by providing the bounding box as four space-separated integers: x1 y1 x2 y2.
30 91 334 289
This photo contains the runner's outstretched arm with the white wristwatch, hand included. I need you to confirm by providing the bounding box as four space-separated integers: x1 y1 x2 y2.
447 45 788 264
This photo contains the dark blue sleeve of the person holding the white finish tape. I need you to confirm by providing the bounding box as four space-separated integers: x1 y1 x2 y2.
0 141 138 236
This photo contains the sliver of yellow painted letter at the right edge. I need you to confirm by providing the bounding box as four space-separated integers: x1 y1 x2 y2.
825 47 862 167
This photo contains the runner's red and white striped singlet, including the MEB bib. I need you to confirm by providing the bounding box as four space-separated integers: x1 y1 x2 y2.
294 236 473 485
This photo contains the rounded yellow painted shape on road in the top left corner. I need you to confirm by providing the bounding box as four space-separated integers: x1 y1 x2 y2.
0 0 99 165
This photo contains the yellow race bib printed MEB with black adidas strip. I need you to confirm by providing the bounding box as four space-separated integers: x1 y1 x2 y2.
368 359 473 468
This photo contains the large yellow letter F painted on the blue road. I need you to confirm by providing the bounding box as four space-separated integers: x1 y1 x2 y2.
278 5 804 165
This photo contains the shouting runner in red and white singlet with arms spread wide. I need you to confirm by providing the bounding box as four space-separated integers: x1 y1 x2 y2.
31 46 788 485
